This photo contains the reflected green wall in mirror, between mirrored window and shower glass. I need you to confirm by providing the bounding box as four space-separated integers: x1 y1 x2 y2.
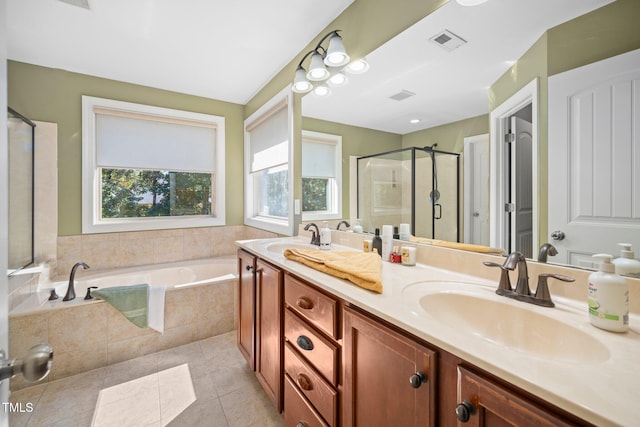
302 117 402 218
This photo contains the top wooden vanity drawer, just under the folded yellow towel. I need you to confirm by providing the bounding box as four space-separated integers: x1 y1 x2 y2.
284 275 339 339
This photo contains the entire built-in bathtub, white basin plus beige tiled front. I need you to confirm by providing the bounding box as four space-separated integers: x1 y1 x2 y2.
9 256 237 390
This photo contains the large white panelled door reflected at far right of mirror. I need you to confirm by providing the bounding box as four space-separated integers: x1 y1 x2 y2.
548 50 640 267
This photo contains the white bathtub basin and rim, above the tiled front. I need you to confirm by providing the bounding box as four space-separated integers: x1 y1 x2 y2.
9 257 237 315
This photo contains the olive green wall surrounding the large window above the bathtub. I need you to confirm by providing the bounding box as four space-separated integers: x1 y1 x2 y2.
8 61 244 236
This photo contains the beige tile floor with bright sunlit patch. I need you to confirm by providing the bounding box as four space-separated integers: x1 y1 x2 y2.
10 332 284 427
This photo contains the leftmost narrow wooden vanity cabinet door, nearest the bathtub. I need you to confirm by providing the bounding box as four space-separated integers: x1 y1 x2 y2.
237 250 256 370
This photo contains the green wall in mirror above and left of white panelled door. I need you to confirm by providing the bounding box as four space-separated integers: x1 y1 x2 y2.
489 0 640 247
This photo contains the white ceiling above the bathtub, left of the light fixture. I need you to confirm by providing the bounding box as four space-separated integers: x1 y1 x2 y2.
7 0 353 104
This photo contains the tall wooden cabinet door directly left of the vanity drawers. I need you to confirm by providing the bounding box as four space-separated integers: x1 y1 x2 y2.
256 259 284 411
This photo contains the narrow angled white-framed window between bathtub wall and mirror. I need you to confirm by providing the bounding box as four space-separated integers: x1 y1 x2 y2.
244 87 294 235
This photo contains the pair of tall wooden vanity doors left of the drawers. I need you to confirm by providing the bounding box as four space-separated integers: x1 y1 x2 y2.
237 250 283 411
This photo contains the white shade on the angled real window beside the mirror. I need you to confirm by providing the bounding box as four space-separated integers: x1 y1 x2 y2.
247 104 289 172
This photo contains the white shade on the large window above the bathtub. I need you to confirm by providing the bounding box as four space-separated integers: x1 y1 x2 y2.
96 112 216 173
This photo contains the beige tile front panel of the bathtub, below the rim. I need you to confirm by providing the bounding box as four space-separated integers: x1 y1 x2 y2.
9 270 236 390
